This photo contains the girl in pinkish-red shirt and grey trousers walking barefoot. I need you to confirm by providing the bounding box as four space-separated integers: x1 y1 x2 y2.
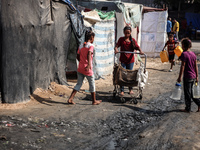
67 31 101 105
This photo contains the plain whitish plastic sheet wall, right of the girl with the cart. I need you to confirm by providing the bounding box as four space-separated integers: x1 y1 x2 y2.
141 11 168 57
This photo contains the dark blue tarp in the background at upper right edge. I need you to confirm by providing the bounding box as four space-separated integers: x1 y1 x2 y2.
185 13 200 29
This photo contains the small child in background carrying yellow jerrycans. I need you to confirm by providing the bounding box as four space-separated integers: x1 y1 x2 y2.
162 34 179 72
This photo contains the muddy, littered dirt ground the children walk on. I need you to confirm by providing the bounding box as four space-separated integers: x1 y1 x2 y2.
0 49 200 150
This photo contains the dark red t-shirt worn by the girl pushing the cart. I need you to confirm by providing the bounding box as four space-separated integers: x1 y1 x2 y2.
117 37 139 64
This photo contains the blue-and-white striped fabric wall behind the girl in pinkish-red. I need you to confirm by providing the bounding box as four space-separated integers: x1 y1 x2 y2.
93 20 115 77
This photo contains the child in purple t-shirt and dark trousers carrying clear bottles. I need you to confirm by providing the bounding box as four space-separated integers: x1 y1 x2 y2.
177 38 200 112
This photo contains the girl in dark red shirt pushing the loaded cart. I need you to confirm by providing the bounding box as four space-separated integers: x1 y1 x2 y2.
115 26 144 96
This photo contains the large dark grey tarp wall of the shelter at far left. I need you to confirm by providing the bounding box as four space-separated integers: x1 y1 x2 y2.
0 0 71 103
